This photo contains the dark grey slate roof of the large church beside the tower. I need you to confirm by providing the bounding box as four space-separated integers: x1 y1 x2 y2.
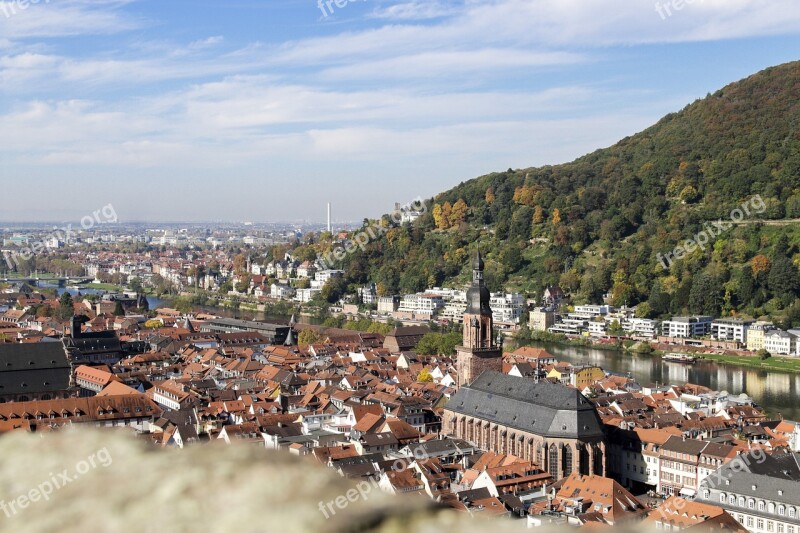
445 371 603 439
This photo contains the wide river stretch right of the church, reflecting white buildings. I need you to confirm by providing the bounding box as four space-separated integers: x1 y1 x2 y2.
537 344 800 420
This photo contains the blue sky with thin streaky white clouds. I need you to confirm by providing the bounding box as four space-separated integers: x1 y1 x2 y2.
0 0 800 222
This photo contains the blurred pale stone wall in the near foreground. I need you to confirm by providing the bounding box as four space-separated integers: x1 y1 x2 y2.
0 429 648 533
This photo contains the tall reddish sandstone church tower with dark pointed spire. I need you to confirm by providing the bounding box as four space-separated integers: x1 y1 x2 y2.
456 252 503 387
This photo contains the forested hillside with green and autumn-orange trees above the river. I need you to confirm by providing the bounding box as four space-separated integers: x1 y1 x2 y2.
334 62 800 322
